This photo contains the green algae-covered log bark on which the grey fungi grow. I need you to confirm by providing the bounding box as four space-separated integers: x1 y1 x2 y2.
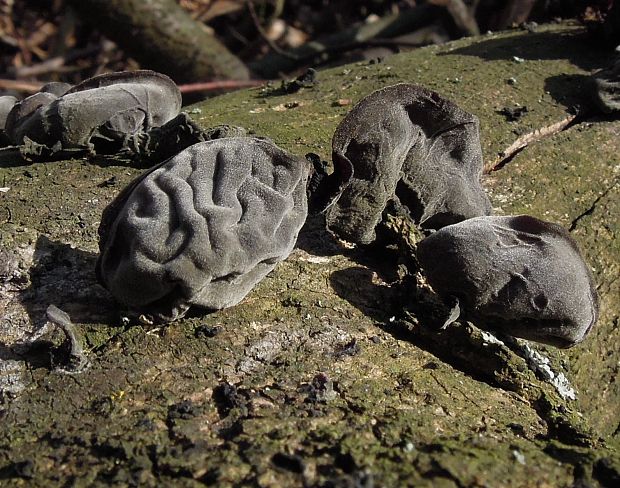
0 26 620 487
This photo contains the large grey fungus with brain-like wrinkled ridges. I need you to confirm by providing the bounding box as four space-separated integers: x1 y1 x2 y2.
97 137 310 321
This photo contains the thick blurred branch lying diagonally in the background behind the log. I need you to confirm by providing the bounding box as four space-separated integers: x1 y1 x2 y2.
69 0 249 83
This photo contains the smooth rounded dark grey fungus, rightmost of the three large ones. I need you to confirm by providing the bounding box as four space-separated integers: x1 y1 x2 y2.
417 215 598 347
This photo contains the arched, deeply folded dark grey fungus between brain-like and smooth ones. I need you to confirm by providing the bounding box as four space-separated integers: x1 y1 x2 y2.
317 84 491 244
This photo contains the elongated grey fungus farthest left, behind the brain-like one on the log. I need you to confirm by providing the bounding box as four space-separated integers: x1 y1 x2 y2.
6 70 181 153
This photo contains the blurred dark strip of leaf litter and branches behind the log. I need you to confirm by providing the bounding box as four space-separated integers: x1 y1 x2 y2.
0 0 618 97
